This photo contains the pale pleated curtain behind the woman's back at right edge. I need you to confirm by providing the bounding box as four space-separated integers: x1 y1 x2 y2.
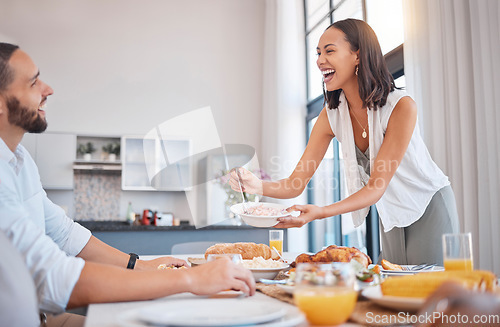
404 0 500 274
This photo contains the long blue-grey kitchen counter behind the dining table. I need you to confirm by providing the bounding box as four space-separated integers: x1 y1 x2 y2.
77 221 288 255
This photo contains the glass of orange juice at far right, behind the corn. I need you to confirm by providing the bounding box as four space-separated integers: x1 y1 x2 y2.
443 233 474 271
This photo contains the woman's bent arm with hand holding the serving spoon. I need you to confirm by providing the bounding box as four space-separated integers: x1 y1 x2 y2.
229 108 335 199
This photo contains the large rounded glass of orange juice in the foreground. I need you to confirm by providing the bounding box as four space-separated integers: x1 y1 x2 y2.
293 262 358 326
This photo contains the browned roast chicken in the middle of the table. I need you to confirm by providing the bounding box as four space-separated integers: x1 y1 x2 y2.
295 245 372 268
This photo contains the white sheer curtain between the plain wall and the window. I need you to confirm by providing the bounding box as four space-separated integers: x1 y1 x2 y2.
261 0 307 252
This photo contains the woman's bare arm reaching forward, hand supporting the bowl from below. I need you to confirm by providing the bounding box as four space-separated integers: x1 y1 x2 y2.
275 97 417 228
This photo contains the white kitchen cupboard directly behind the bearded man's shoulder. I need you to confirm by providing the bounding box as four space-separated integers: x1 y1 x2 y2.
21 133 76 190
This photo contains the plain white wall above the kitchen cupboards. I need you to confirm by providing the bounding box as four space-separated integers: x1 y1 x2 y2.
0 0 265 150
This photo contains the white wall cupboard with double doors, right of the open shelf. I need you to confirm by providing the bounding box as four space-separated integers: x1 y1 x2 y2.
121 136 192 191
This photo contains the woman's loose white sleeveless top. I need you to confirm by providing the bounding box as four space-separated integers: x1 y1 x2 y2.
327 89 450 232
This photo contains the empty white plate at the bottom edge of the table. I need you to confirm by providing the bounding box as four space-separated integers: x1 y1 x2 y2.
136 299 286 326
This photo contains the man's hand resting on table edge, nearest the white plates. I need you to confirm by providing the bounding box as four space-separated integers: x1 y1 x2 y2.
183 258 255 295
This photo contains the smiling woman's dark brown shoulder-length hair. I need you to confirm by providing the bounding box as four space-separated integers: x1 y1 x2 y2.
323 18 395 110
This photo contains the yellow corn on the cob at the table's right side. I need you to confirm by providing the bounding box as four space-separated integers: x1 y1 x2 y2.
381 270 497 298
